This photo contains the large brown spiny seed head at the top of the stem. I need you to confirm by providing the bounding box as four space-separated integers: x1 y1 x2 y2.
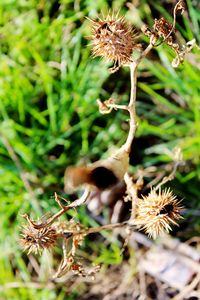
89 15 140 73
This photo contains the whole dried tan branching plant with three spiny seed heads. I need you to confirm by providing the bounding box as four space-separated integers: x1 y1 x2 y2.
21 0 195 278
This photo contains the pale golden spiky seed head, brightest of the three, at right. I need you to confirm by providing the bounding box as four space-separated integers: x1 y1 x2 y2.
135 189 182 239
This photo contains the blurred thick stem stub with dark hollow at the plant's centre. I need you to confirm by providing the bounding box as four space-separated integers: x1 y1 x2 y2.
64 149 129 193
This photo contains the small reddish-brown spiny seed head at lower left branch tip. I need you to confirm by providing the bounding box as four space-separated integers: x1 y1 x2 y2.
20 225 58 254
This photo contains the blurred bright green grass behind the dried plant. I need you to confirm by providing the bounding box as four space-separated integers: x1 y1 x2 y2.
0 0 200 299
